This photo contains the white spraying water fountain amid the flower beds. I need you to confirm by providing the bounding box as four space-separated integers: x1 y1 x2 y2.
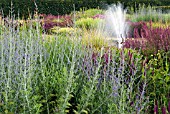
103 3 128 48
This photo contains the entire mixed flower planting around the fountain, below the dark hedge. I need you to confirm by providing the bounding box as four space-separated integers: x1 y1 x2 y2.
0 3 170 114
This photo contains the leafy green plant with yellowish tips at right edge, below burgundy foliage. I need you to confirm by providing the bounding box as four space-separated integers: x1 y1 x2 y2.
146 51 170 114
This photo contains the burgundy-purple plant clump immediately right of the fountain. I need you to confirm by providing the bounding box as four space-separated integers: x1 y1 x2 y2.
124 22 170 55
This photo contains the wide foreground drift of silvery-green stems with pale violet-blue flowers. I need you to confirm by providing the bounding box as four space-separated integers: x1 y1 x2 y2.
0 17 147 114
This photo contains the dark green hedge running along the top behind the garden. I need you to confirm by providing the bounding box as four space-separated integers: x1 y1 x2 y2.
0 0 170 18
